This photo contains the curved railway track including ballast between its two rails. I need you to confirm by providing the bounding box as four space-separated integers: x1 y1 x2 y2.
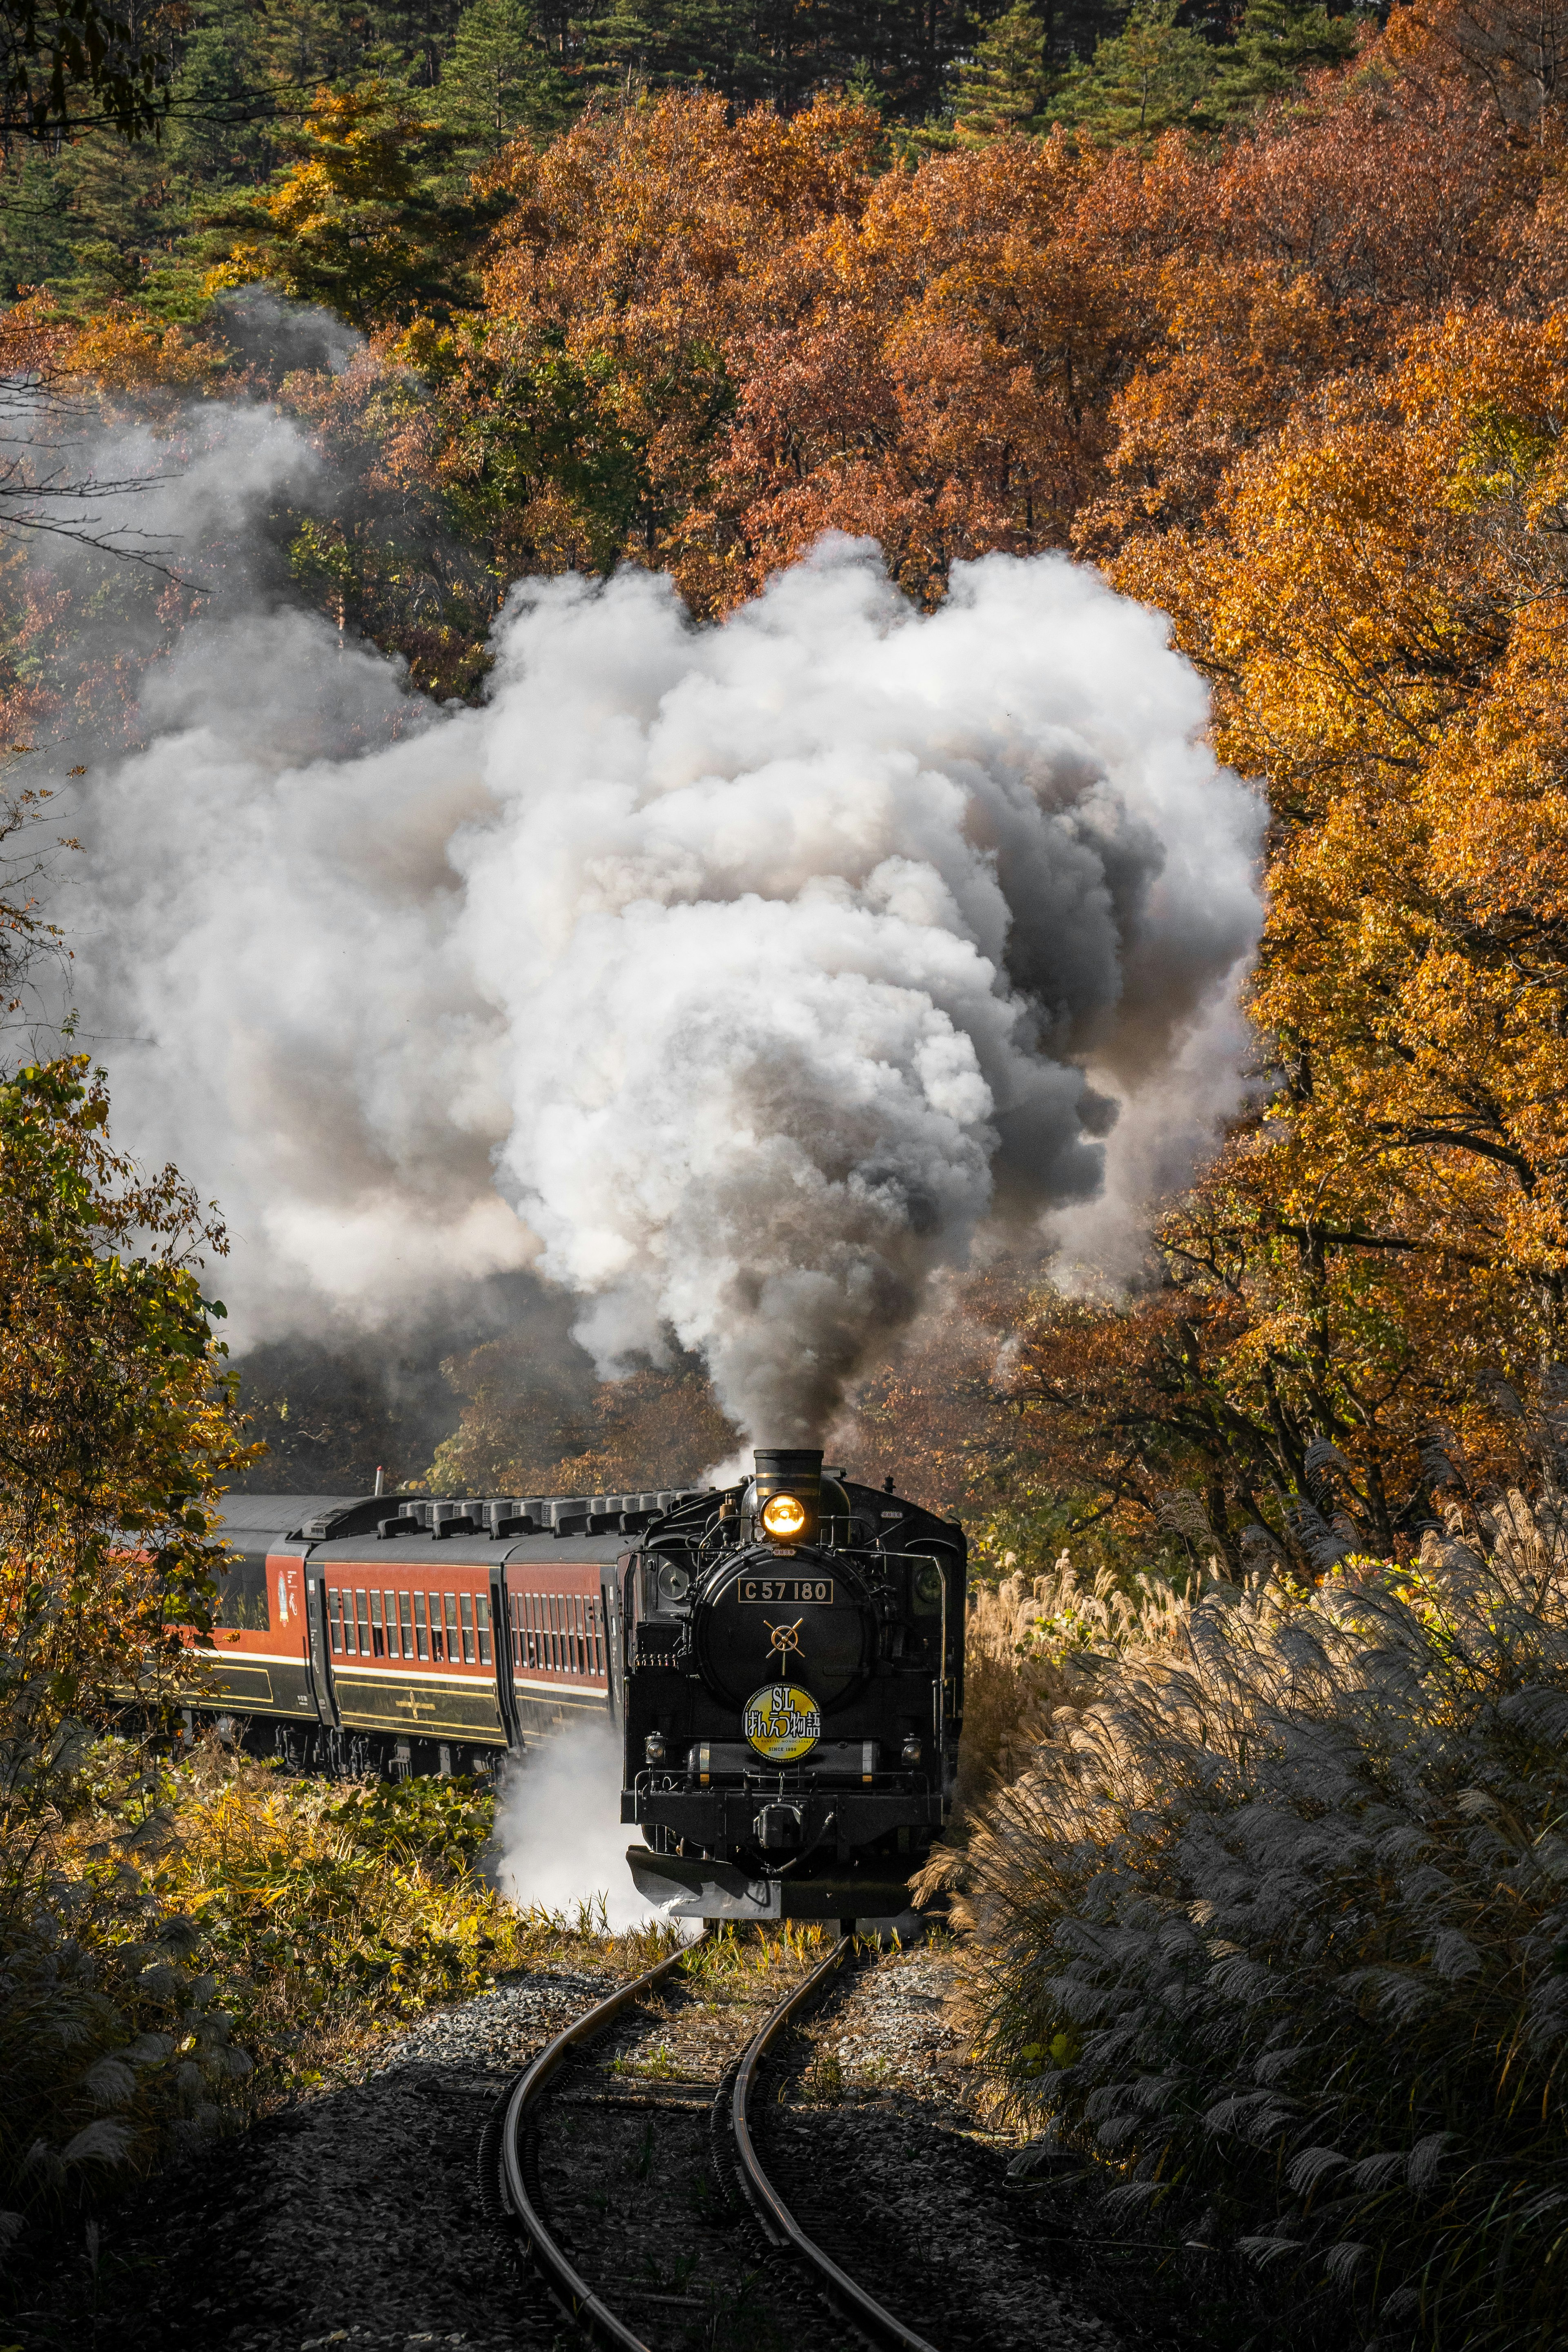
479 1938 935 2352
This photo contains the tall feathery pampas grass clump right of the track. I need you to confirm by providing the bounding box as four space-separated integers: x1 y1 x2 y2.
947 1477 1568 2352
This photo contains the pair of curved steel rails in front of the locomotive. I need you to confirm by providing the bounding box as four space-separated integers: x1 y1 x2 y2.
479 1938 935 2352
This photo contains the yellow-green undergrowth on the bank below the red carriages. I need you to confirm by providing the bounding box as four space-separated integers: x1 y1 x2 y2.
0 1738 668 2246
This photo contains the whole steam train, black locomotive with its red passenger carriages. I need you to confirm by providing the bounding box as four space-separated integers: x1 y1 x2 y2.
186 1449 966 1919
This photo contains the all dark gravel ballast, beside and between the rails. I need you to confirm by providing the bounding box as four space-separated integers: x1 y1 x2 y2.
7 1947 1119 2352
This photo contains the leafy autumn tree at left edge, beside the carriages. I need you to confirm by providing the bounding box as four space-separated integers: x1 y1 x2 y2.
0 1056 249 1750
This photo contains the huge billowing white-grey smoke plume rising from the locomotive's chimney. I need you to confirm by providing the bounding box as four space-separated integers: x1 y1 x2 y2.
27 407 1260 1442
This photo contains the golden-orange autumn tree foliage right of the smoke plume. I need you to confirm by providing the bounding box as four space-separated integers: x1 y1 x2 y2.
1022 308 1568 1559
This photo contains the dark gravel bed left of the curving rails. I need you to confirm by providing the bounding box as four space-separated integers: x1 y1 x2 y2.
7 1969 616 2352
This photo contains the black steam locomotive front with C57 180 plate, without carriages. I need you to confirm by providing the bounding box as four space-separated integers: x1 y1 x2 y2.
621 1446 966 1919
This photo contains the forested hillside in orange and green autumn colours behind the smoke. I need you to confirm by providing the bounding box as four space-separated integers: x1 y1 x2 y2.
0 0 1568 1573
